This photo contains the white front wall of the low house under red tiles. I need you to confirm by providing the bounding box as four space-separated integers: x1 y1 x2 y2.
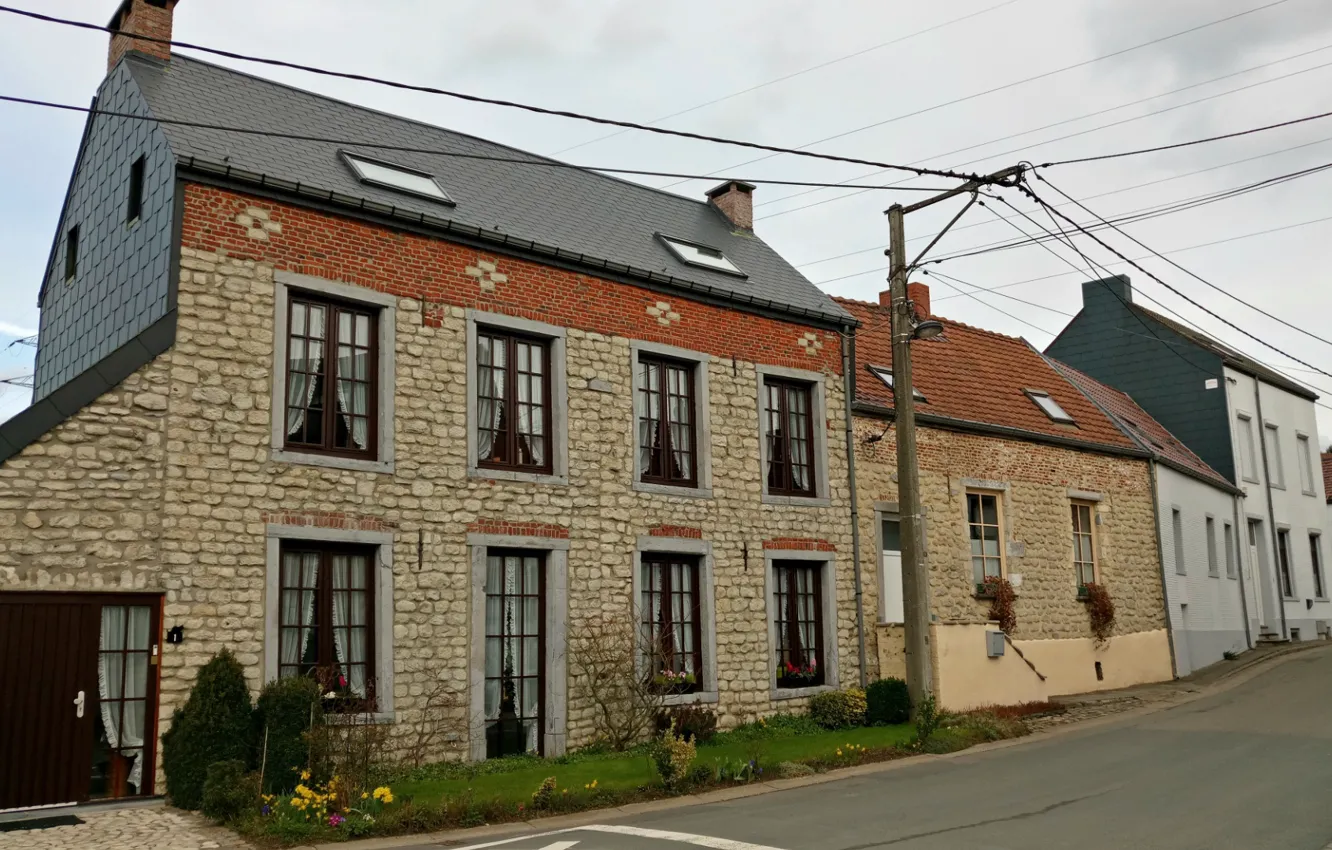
1156 464 1257 675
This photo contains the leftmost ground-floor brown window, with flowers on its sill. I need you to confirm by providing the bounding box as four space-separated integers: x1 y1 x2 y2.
277 541 376 711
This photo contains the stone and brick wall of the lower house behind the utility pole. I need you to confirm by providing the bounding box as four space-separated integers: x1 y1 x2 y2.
855 418 1166 652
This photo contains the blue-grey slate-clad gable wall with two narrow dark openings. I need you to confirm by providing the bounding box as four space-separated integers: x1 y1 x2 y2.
33 61 176 401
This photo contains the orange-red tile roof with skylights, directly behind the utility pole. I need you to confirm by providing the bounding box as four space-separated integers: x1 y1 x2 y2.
835 298 1139 449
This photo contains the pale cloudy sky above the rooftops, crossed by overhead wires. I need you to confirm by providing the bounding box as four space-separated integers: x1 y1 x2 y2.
0 0 1332 446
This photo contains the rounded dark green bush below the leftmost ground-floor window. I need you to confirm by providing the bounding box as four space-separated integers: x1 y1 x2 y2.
254 675 324 794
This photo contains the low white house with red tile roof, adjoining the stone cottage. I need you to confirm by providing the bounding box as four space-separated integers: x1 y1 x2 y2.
1052 360 1256 675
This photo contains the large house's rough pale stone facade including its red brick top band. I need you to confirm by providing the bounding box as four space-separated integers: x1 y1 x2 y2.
0 187 856 778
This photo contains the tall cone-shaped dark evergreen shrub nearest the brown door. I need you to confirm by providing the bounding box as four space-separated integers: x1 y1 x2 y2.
163 650 252 810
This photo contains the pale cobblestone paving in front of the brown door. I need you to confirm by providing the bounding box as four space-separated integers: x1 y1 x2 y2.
0 805 250 850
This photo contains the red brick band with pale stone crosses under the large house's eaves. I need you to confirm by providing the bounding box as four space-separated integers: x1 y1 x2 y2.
181 184 842 374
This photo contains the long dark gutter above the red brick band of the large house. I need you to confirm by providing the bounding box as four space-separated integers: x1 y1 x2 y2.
177 156 859 330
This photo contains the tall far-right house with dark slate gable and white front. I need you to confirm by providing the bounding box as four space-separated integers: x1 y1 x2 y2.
1046 276 1332 641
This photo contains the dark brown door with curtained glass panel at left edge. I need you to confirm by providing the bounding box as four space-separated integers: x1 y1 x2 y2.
0 592 160 810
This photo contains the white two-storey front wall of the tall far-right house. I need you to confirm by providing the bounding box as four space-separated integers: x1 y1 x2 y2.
1220 366 1332 641
